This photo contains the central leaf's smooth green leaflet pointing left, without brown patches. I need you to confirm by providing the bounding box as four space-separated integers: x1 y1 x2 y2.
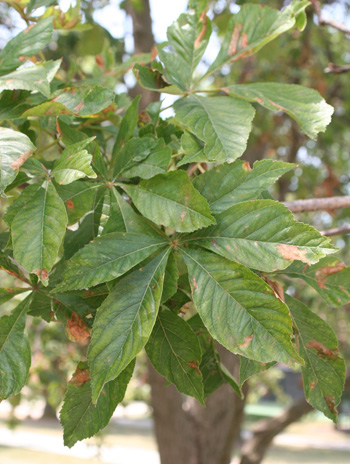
56 232 169 292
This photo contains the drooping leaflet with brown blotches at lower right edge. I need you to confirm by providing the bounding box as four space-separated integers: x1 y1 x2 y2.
286 295 345 421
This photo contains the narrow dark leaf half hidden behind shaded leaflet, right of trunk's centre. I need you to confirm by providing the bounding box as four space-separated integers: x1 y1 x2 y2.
188 314 243 398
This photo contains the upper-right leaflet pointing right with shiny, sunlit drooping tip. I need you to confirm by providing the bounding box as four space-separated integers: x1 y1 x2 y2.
225 82 334 139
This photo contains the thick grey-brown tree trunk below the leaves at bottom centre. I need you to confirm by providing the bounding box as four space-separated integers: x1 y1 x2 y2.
149 347 244 464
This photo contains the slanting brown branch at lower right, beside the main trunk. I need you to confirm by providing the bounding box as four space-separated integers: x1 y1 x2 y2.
240 399 312 464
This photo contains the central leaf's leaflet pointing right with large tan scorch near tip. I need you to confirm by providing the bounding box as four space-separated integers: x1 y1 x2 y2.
183 200 337 272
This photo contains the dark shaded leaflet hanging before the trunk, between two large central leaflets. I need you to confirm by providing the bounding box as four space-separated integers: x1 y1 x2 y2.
146 308 204 404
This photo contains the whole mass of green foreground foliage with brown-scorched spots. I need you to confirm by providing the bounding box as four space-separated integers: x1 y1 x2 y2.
0 0 350 446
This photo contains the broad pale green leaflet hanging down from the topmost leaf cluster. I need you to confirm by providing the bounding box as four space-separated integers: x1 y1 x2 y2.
174 95 255 163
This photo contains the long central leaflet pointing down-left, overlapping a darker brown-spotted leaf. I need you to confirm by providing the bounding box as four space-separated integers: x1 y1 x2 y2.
88 248 170 401
